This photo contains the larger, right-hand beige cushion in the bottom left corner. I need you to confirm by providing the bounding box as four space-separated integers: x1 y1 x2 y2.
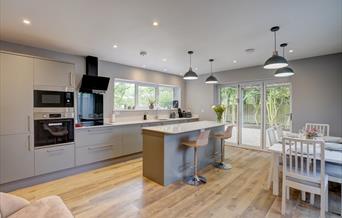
9 196 73 218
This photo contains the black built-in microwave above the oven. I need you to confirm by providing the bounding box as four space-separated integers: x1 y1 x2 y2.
33 90 74 108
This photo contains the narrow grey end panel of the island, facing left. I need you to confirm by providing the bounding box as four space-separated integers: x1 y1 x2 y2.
142 130 164 185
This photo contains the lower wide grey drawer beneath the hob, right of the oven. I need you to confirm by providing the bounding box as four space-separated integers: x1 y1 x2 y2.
76 144 122 166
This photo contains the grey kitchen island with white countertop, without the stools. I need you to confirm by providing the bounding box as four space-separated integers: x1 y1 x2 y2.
142 121 224 186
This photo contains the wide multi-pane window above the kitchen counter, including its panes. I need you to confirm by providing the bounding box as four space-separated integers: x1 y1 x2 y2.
114 79 180 110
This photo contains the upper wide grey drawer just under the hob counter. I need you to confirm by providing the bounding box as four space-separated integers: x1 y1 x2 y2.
76 128 121 147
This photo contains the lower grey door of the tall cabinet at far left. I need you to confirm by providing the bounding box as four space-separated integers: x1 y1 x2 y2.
0 134 34 184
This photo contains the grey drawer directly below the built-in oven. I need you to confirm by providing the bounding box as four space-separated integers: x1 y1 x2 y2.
34 144 75 175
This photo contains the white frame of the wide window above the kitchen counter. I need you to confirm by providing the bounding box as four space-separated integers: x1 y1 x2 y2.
113 78 181 112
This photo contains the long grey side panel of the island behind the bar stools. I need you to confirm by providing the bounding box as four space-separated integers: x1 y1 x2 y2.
163 126 224 185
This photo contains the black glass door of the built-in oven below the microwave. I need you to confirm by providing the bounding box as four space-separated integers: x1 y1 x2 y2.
34 118 74 147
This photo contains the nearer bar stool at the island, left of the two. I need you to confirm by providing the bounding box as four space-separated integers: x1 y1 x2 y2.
182 130 210 186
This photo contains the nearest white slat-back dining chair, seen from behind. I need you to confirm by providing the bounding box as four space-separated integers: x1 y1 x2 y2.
281 137 328 218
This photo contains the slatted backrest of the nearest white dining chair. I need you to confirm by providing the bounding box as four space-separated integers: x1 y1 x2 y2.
282 137 325 182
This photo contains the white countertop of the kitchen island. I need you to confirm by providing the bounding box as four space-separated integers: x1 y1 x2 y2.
142 121 225 134
